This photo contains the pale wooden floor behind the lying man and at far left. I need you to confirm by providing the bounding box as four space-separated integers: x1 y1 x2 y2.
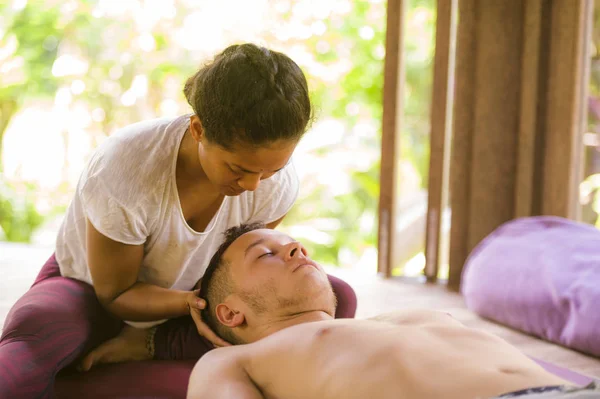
0 243 600 377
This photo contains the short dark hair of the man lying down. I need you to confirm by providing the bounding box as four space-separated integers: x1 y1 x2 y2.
200 222 266 344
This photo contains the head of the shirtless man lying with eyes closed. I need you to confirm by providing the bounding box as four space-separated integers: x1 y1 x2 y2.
200 223 336 344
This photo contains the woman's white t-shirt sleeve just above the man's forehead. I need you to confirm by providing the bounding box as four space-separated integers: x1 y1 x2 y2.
248 163 300 224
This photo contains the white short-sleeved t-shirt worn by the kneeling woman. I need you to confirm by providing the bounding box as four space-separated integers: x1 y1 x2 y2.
56 115 299 324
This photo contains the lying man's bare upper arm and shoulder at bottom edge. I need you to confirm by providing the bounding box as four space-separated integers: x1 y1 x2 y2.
187 347 264 399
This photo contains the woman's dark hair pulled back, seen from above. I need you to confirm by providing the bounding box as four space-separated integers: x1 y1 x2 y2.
183 43 312 150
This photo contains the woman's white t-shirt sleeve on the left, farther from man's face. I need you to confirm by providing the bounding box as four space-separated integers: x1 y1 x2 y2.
78 149 148 245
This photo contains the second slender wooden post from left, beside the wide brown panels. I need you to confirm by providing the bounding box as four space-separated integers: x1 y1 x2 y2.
425 0 458 282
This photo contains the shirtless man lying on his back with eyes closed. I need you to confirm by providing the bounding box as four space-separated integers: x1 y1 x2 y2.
188 224 600 399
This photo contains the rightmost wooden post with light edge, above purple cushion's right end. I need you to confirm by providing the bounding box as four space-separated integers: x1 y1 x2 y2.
541 0 593 220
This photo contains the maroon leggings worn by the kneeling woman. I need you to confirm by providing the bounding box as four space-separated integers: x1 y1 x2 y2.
0 255 356 399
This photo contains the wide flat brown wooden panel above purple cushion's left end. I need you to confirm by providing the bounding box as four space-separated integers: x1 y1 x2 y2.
466 0 524 253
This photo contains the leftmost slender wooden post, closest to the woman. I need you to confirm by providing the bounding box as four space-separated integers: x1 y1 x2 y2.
377 0 405 277
